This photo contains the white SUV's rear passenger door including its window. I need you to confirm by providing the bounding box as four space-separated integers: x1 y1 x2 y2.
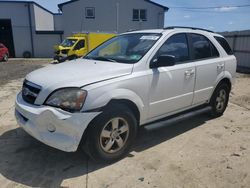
188 33 225 105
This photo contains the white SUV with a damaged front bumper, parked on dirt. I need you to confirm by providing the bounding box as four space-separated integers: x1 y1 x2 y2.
16 27 236 162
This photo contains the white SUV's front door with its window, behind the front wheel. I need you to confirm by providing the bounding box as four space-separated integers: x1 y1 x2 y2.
149 33 195 118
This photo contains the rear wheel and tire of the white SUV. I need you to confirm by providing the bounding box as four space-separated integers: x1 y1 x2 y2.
210 83 230 118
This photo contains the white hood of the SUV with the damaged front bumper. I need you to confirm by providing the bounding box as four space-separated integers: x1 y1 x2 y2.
26 59 133 90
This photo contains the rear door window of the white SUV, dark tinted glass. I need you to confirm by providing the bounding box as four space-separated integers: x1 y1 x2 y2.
190 34 219 60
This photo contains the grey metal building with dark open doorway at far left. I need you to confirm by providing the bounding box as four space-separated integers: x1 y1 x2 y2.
0 1 63 57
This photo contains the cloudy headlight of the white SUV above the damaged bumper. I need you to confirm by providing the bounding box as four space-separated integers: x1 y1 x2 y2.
45 88 87 112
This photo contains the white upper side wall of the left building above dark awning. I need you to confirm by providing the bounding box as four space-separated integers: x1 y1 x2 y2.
32 4 54 31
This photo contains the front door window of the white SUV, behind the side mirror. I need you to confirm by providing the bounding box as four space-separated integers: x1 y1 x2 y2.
156 33 189 64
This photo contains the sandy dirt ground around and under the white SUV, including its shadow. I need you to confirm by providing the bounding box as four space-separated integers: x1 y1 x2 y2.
0 60 250 188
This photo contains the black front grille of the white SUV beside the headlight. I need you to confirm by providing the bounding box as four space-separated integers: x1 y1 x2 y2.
22 80 41 104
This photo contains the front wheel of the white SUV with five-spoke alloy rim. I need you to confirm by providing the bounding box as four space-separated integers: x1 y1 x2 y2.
84 104 138 163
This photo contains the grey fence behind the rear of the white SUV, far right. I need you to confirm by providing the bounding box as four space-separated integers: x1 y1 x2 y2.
221 30 250 73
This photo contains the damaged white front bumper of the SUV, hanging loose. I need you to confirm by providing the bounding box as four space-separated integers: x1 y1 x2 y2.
15 93 100 152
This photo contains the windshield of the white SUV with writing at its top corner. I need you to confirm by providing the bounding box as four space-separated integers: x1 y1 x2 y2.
84 33 161 63
